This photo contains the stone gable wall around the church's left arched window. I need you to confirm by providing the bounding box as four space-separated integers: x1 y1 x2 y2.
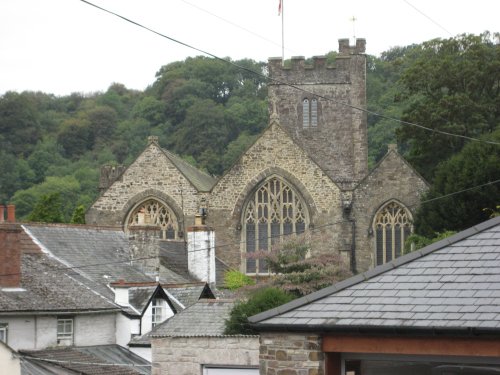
85 141 200 230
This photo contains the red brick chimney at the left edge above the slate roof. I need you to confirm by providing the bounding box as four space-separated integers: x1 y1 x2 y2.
0 223 21 288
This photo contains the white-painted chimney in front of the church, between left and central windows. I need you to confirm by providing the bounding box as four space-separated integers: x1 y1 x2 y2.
186 209 215 283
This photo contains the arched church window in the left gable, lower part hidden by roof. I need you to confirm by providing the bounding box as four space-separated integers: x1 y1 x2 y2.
127 199 179 240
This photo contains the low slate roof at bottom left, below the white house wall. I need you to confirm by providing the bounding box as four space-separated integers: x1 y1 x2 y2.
19 345 151 375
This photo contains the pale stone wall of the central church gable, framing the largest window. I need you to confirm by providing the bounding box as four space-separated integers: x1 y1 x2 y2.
207 122 342 267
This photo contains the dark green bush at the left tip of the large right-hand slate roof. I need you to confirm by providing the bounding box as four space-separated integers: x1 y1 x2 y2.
224 288 294 335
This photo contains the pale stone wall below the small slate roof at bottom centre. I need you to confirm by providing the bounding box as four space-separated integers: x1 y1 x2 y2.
151 336 259 375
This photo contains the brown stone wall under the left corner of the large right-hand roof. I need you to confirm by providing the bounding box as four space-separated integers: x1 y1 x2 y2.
259 332 325 375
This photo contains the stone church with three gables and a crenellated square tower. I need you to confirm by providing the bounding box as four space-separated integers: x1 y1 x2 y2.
86 39 428 280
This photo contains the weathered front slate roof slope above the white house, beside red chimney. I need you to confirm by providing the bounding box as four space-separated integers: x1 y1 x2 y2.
0 254 119 314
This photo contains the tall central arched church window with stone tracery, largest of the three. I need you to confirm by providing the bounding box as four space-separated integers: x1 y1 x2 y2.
242 177 309 274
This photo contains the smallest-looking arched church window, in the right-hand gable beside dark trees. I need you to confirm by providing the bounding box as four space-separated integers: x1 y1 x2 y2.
373 202 412 265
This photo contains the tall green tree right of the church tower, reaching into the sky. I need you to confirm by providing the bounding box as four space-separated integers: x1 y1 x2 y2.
397 32 500 181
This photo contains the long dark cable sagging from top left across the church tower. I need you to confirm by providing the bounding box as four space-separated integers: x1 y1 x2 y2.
80 0 500 146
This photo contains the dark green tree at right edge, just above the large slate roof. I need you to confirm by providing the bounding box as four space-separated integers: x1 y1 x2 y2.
415 128 500 237
